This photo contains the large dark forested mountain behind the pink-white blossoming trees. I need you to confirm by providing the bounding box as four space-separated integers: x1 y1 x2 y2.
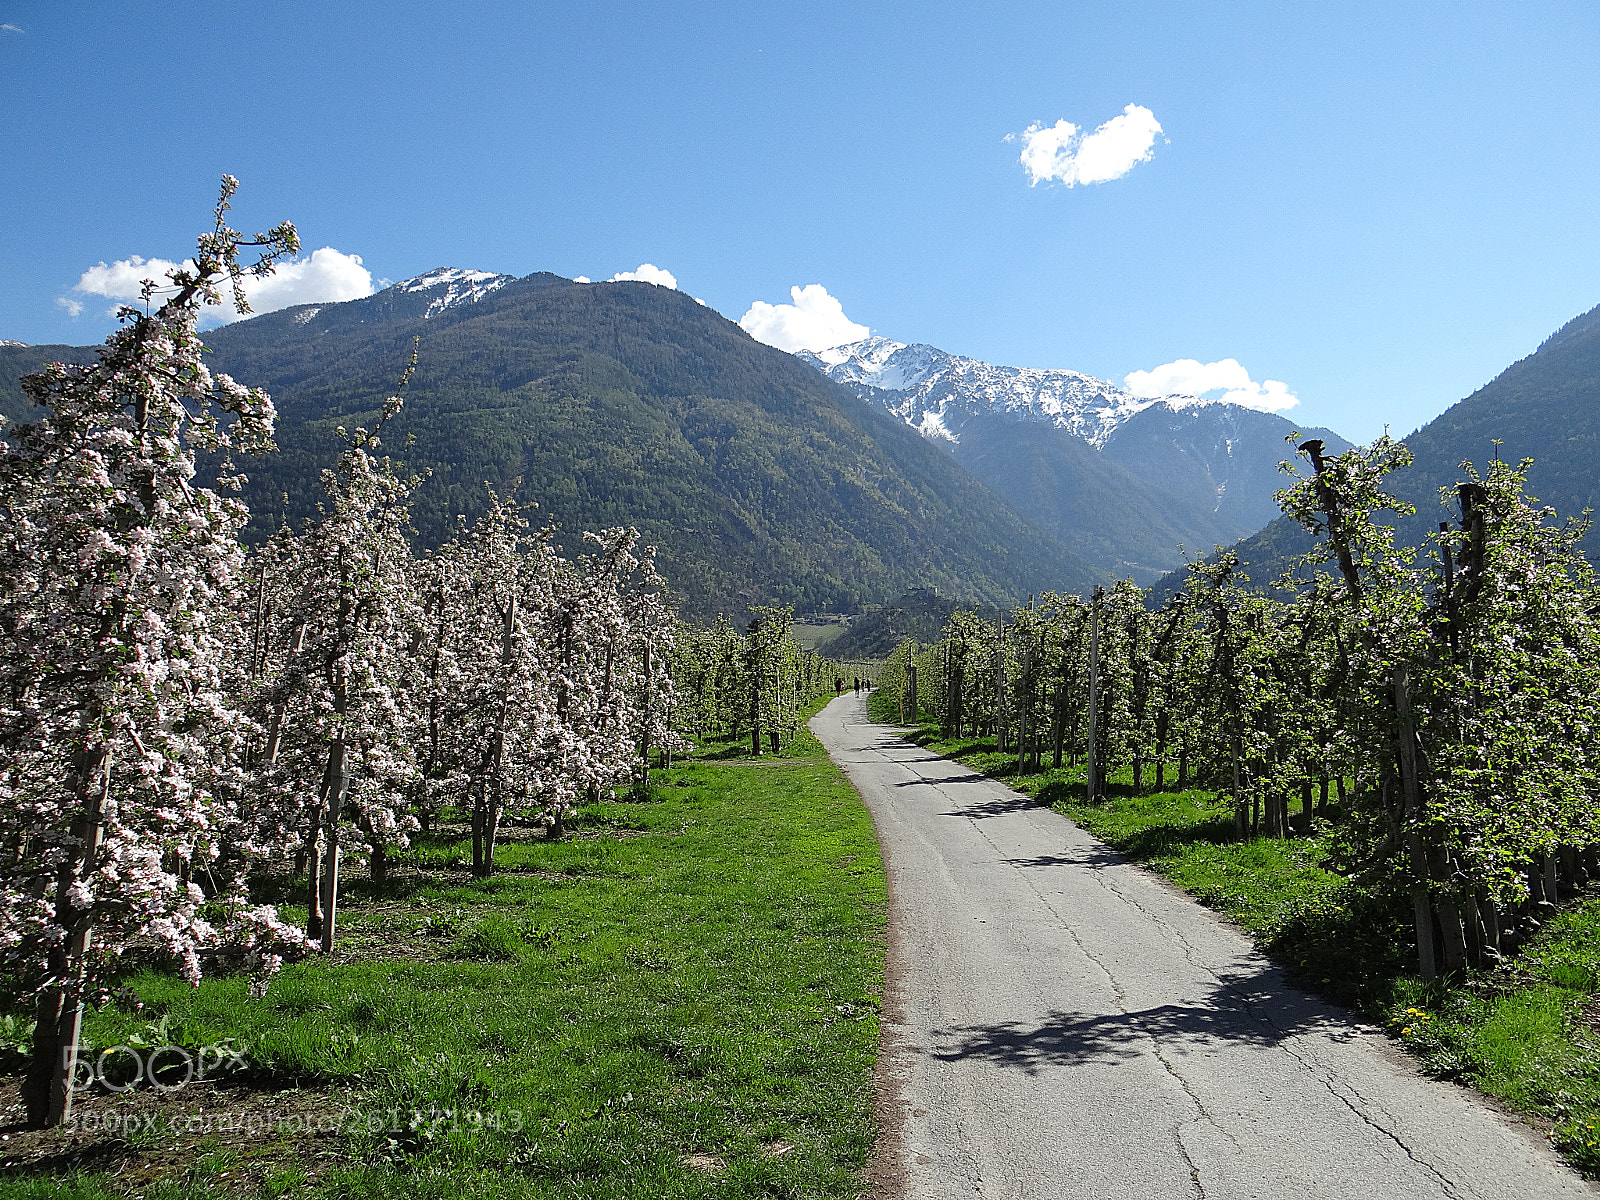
0 269 1104 616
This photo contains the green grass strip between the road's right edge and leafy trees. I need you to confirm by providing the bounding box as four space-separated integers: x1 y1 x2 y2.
874 696 1600 1178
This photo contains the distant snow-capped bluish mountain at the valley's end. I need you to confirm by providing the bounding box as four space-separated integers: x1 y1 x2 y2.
798 338 1349 582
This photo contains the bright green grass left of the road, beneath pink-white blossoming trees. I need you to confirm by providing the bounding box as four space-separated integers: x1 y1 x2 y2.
0 710 885 1200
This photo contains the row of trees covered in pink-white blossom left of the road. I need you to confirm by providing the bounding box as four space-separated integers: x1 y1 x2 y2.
0 188 832 1125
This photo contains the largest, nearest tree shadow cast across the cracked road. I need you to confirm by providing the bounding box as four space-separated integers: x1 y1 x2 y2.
933 970 1362 1075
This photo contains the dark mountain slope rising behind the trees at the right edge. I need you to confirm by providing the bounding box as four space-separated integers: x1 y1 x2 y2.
1158 307 1600 592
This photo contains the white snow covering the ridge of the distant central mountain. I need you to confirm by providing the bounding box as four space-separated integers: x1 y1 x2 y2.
798 338 1221 450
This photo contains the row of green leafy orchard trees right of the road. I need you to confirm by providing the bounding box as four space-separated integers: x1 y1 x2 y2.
882 438 1600 976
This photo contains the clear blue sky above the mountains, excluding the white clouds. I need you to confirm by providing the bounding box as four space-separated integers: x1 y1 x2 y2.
0 0 1600 453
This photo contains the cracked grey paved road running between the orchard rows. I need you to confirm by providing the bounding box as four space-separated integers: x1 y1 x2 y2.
811 696 1600 1200
